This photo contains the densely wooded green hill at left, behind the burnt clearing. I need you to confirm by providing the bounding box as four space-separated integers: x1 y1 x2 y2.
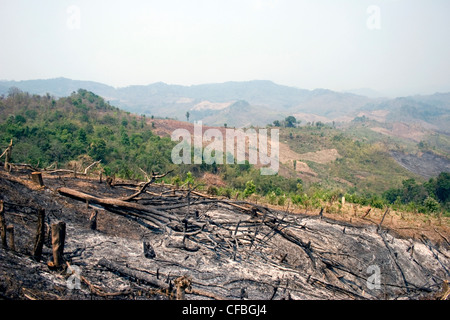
0 89 172 178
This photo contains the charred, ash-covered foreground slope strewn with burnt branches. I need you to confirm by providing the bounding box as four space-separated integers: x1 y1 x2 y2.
0 171 450 300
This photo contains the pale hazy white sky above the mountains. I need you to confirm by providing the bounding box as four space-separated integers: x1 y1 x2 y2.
0 0 450 95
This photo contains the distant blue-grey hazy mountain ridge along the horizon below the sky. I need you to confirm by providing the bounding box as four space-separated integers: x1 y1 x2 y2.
0 78 450 132
